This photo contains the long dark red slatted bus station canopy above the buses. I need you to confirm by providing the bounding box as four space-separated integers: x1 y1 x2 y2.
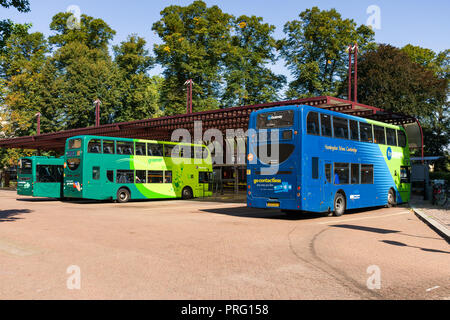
0 96 422 151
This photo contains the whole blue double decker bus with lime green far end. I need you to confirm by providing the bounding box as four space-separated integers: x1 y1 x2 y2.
247 106 411 216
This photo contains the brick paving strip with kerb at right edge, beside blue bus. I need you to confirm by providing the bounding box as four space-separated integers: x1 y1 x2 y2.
409 197 450 243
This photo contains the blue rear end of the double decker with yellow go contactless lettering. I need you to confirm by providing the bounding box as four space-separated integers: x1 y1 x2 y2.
247 107 301 210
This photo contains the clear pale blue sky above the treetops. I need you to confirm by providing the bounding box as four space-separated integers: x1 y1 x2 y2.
0 0 450 80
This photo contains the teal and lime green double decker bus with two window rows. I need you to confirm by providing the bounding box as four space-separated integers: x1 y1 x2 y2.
64 136 212 203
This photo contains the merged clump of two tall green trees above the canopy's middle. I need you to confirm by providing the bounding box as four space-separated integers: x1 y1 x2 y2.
153 1 284 114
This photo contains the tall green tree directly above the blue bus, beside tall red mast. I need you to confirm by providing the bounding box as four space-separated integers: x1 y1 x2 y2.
278 7 375 98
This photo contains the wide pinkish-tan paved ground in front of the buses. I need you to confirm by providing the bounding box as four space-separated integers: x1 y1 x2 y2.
0 191 450 299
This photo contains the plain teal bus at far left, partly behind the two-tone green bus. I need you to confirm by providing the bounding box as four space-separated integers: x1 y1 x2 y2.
17 156 64 198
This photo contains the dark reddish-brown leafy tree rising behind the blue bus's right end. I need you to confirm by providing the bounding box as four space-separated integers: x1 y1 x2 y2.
358 45 450 161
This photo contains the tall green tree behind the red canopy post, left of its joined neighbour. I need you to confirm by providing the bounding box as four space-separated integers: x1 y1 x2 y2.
152 1 232 115
